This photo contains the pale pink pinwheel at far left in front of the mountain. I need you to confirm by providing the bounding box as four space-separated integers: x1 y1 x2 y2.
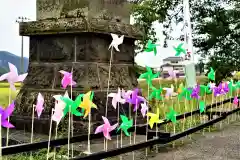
0 62 27 91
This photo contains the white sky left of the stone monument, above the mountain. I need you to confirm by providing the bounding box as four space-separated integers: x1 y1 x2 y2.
0 0 36 57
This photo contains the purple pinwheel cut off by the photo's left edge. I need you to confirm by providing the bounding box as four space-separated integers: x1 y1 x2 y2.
0 101 15 128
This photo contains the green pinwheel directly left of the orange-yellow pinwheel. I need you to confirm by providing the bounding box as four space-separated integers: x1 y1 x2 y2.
60 94 84 117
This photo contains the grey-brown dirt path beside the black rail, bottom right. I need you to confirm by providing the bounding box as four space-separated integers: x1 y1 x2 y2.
148 122 240 160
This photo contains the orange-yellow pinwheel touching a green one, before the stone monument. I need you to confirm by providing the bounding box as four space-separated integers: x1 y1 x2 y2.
79 91 97 118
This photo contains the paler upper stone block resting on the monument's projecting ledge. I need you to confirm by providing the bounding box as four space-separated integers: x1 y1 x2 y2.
37 0 131 24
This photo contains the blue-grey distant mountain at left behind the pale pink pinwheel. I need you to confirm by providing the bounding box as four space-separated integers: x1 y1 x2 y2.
0 51 29 74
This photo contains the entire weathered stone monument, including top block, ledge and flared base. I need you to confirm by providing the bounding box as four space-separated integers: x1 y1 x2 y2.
12 0 142 134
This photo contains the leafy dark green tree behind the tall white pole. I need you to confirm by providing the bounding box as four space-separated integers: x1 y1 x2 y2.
133 0 240 81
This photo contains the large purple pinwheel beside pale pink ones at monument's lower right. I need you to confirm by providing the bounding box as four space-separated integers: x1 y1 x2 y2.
126 88 146 112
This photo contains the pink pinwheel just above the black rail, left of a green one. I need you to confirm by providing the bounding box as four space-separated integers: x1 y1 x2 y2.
95 116 118 140
